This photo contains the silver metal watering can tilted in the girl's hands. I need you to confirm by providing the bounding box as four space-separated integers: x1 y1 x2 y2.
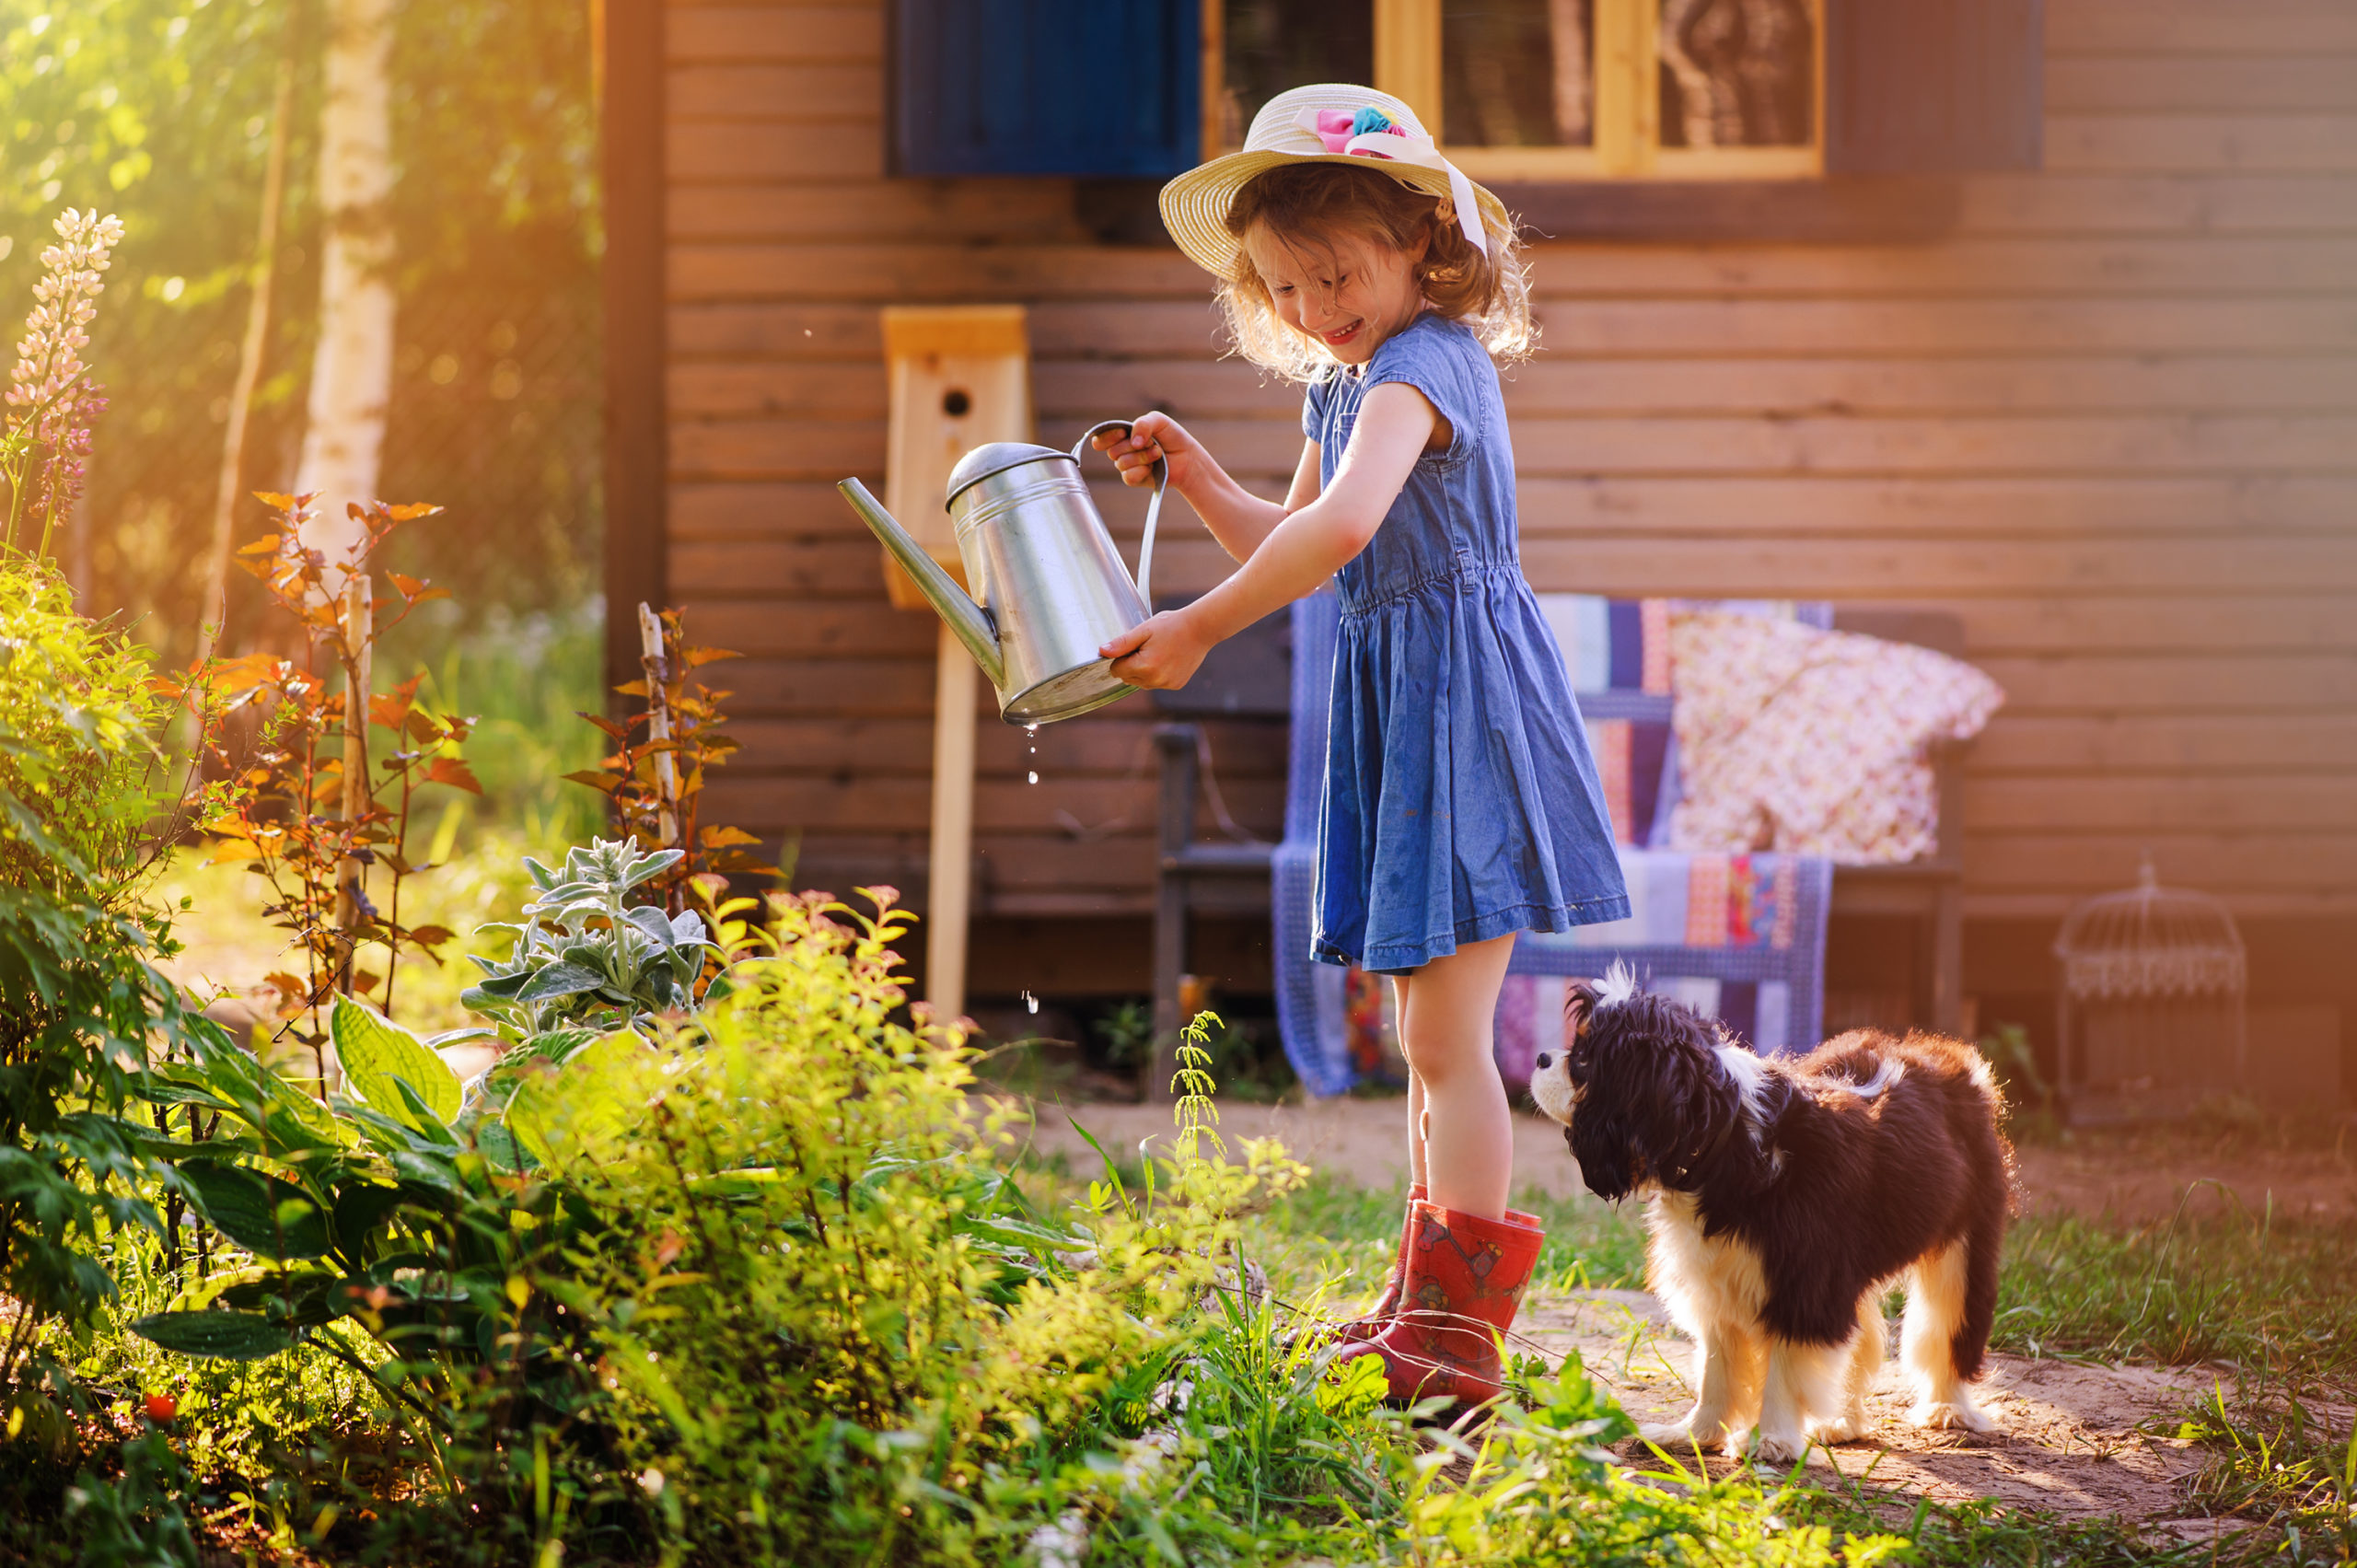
834 420 1169 724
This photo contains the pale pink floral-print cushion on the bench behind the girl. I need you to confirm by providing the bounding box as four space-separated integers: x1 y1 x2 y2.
1668 609 2006 865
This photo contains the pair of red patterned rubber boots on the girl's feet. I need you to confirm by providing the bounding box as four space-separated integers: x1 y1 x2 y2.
1341 1202 1546 1405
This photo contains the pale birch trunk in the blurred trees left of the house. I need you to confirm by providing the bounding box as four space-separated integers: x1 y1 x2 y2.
295 0 394 577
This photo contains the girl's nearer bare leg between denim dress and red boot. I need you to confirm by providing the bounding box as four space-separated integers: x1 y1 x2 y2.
1393 934 1514 1219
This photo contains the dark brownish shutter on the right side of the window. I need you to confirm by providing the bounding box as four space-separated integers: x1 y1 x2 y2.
1824 0 2046 175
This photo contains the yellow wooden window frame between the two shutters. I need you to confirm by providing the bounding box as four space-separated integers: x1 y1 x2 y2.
1202 0 1827 181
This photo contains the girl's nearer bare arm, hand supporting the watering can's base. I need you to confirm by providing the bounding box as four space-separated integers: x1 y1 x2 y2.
1101 382 1440 689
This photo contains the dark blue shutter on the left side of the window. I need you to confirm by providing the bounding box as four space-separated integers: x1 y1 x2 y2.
891 0 1202 180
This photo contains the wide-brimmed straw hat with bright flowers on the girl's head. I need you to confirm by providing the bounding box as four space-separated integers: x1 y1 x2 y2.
1162 83 1514 273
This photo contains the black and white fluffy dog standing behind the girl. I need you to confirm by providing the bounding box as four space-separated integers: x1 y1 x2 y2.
1529 967 2013 1462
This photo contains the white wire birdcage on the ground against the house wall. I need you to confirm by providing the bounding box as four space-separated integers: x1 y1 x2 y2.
2055 856 2247 1120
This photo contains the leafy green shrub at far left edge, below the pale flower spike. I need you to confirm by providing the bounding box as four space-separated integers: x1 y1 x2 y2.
0 554 195 1420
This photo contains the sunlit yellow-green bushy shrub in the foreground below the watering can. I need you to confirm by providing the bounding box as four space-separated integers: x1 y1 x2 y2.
509 900 1291 1563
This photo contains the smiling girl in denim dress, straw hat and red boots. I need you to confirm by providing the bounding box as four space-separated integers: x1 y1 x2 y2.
1098 85 1629 1403
